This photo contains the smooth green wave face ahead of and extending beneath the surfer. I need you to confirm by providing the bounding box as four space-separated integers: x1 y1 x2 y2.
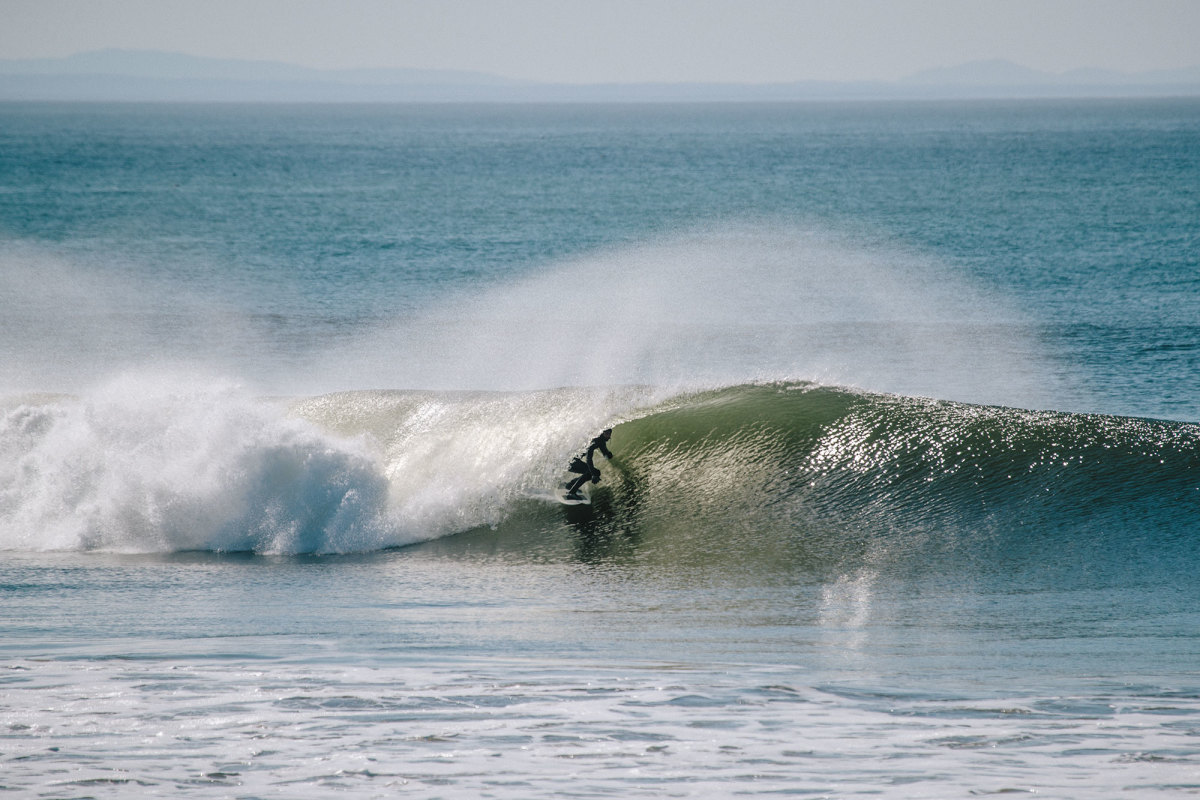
472 384 1200 581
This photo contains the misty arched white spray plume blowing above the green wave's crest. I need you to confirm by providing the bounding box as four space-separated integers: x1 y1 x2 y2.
317 225 1049 407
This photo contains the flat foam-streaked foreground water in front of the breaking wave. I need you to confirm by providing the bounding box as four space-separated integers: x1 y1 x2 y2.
4 542 1200 798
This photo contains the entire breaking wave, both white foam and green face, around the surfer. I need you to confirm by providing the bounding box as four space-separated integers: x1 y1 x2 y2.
0 379 1200 573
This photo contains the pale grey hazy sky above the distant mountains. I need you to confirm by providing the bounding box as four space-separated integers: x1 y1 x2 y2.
0 0 1200 84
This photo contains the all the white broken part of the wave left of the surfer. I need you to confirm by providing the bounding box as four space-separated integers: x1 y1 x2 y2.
0 373 643 553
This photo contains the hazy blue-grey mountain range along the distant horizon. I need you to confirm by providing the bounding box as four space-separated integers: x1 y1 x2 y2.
0 50 1200 102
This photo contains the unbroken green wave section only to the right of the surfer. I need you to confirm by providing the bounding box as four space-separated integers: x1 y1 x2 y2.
609 384 1200 561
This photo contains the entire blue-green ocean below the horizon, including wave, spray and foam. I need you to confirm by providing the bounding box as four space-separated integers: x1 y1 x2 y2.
0 98 1200 799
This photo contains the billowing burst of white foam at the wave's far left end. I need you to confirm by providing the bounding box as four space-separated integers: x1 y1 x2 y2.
0 375 388 553
